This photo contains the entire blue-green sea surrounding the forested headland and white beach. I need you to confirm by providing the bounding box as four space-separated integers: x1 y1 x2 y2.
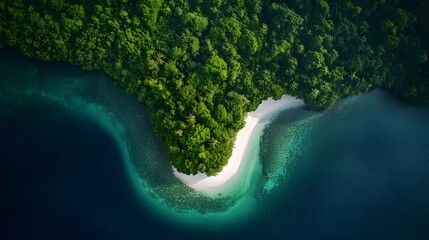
0 50 429 239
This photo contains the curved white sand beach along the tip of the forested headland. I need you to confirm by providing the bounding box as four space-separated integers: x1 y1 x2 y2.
173 95 304 193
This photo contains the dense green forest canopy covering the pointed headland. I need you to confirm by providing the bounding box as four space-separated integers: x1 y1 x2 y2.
0 0 429 175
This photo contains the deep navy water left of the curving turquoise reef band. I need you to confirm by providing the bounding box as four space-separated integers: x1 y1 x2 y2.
0 108 138 239
